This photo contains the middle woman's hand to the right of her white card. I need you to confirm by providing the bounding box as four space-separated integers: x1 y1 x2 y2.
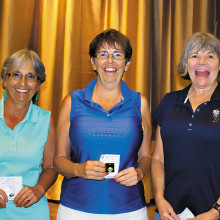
113 167 142 186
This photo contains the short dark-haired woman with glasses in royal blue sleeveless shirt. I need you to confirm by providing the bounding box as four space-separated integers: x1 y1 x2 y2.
54 29 151 220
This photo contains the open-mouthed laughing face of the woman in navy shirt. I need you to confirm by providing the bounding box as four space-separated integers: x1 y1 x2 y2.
187 48 220 89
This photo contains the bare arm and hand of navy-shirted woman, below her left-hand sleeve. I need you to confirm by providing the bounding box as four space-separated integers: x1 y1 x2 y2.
151 126 180 220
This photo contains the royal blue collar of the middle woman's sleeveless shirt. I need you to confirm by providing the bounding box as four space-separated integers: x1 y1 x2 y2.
84 78 131 102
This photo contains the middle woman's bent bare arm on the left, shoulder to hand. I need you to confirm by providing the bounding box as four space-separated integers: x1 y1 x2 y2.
54 95 107 180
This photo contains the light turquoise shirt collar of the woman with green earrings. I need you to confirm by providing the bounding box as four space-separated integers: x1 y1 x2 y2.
0 98 38 123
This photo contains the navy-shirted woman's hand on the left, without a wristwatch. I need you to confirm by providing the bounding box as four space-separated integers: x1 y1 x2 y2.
157 198 180 220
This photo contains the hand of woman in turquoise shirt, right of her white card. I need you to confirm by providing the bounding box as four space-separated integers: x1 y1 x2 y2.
13 186 44 208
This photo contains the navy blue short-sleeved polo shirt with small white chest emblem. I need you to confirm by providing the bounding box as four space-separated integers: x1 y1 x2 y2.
155 85 220 215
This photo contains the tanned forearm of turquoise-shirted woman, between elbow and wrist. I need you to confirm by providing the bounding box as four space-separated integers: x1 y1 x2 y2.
36 168 57 194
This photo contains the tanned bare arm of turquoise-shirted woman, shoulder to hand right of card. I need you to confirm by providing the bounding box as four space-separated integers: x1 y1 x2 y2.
14 118 57 208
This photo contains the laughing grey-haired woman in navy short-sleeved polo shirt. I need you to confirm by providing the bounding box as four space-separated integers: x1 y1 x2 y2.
151 33 220 220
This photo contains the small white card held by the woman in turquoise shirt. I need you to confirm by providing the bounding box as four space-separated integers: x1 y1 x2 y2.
0 176 22 200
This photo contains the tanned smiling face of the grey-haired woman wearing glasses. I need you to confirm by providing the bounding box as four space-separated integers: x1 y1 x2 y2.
4 60 40 104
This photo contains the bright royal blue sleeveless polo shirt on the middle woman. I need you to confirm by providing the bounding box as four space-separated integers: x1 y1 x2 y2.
61 79 145 214
